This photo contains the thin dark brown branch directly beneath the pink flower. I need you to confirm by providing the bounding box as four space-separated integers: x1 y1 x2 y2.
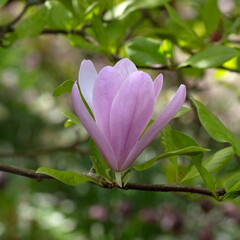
0 163 226 197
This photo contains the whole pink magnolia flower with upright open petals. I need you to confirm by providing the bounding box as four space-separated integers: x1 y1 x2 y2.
72 58 186 171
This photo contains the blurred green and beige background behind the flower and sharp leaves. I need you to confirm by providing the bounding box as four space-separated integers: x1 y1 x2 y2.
0 0 240 240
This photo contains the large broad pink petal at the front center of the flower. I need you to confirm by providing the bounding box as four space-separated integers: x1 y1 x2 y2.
110 71 155 168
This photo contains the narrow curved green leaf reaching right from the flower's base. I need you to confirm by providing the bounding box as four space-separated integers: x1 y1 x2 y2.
133 146 209 171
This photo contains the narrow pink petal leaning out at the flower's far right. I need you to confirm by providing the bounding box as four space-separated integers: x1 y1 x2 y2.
120 84 186 171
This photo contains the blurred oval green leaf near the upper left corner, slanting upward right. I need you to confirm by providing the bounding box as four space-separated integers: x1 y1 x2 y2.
15 7 47 39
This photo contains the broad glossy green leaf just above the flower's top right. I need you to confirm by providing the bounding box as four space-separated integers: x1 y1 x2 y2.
126 38 166 66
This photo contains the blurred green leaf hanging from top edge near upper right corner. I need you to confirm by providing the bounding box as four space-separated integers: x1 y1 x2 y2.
200 0 221 34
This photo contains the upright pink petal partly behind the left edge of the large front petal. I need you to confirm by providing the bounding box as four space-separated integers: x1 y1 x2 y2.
93 66 123 139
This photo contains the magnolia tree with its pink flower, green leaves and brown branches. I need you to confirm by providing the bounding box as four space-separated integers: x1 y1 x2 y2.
0 0 240 205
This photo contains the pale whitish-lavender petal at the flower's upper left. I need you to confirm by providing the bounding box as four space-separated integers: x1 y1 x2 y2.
78 60 97 110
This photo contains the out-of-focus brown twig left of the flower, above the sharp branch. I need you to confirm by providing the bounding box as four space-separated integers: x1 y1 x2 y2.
0 139 88 158
